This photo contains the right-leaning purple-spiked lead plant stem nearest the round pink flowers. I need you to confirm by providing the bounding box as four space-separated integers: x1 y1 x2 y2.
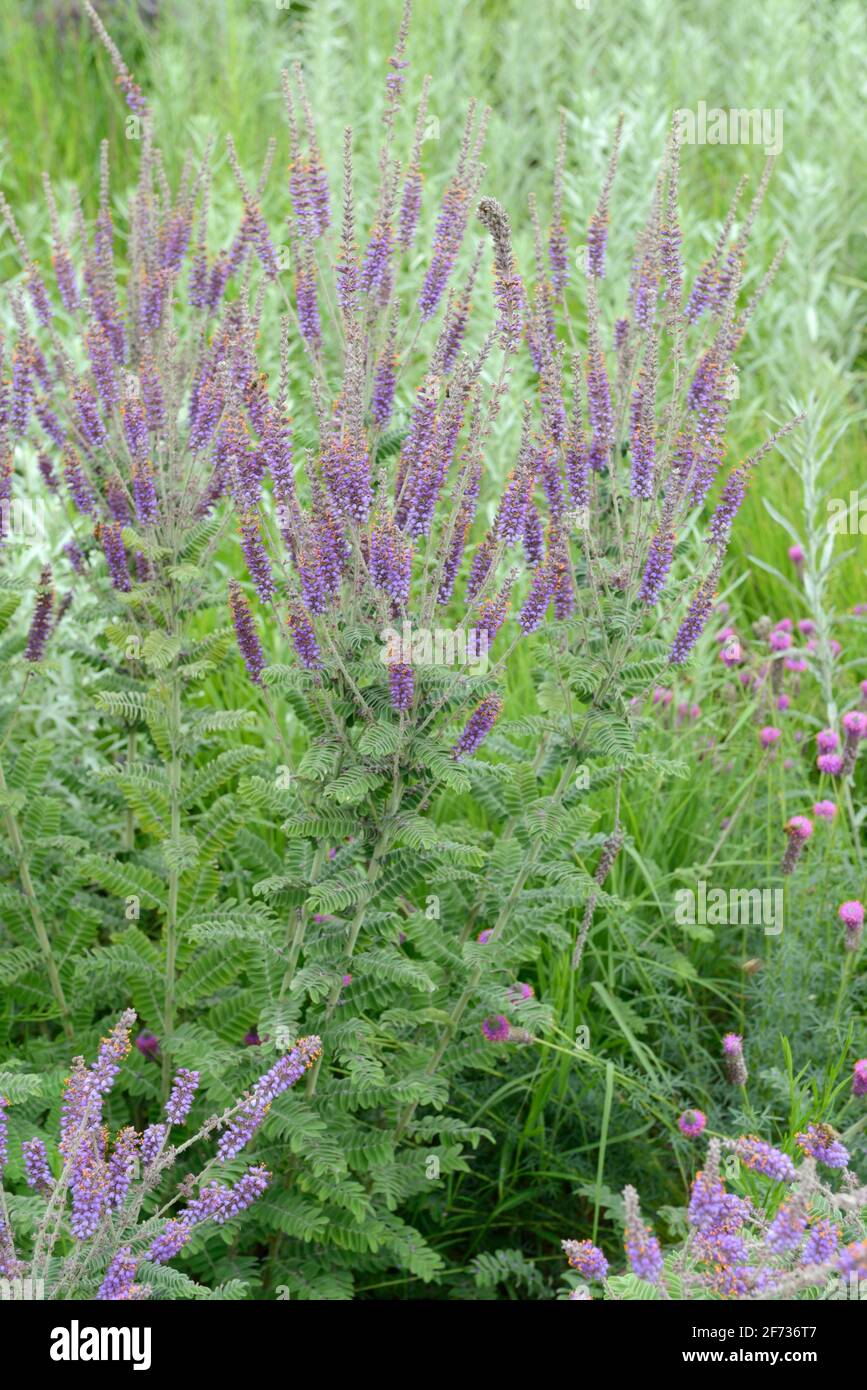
391 116 798 1126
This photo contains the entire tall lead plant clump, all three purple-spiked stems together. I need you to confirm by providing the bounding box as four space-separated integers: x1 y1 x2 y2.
6 7 816 1297
